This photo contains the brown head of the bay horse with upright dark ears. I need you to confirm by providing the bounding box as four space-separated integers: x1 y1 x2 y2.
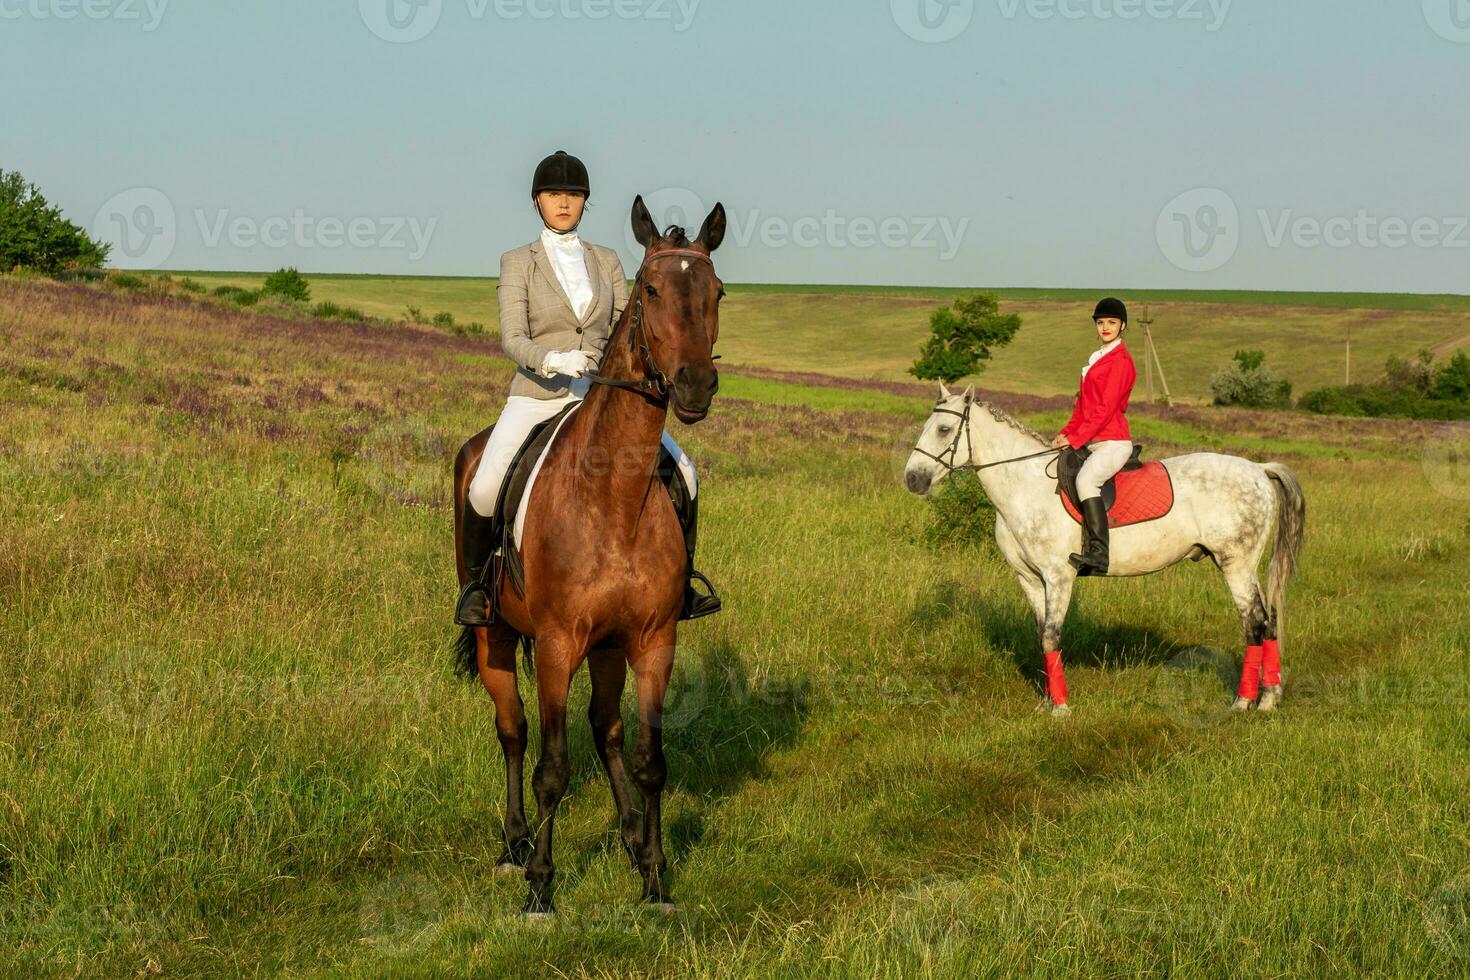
629 195 725 423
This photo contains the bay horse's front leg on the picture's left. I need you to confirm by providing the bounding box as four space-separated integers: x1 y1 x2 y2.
525 633 587 917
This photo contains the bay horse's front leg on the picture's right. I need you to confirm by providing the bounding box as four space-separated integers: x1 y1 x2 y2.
628 627 675 907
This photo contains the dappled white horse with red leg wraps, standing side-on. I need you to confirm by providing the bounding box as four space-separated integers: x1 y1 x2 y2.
904 383 1307 717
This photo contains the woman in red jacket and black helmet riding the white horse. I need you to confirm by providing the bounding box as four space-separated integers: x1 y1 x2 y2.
1051 297 1138 574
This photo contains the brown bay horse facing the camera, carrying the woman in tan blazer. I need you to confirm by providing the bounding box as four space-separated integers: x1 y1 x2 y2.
454 195 725 917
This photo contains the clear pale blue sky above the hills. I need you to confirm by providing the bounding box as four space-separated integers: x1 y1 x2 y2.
0 0 1470 294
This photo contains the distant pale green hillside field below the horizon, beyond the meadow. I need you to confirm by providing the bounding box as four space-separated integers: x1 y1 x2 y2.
160 273 1470 403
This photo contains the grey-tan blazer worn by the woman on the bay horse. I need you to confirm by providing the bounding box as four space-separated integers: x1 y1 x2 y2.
495 238 628 398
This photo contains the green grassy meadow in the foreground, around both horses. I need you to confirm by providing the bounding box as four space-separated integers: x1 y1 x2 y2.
0 278 1470 977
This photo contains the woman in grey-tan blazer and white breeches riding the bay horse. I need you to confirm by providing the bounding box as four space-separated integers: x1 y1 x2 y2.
456 150 720 626
